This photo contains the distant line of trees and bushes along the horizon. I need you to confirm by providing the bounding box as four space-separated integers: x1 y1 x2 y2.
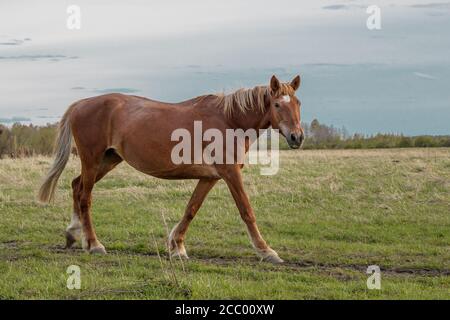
0 119 450 158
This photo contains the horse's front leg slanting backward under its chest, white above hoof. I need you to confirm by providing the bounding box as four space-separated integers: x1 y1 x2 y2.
168 179 218 258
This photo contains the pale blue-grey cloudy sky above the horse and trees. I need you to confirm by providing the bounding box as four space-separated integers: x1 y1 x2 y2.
0 0 450 135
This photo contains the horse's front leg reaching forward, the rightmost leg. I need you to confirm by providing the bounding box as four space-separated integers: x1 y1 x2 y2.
220 165 283 263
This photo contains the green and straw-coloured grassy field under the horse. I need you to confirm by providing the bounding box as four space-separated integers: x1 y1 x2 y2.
0 149 450 299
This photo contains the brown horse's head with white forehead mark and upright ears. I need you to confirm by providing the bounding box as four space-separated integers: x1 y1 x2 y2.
269 76 305 149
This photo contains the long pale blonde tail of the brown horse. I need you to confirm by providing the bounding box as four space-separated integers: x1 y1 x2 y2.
38 104 75 202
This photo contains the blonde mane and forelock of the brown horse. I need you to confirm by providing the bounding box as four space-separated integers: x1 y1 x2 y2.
217 83 295 116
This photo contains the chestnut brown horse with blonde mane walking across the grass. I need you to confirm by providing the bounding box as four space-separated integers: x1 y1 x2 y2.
39 76 304 263
